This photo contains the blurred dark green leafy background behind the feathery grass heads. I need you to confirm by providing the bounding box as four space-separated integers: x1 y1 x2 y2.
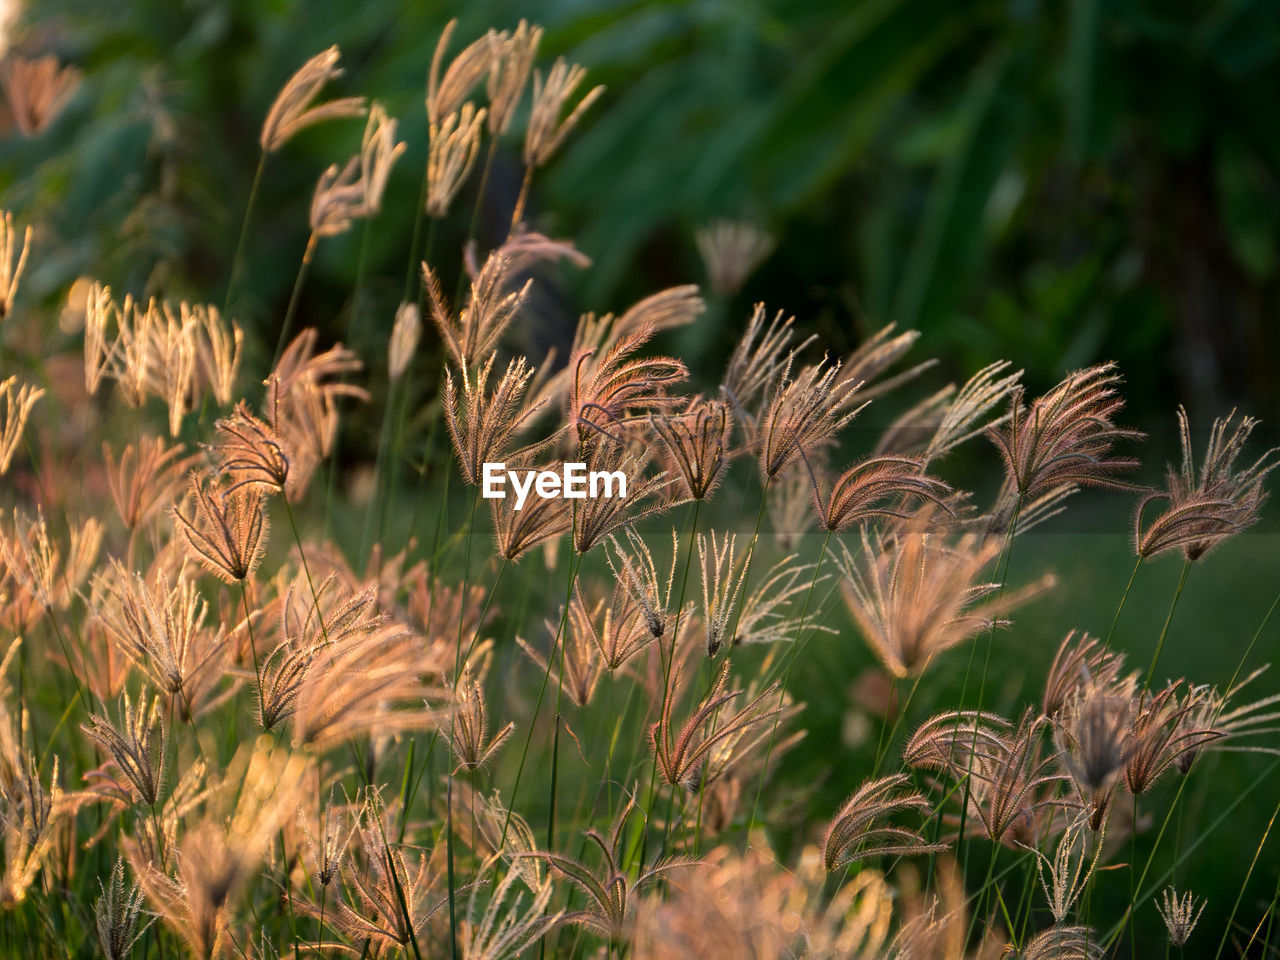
0 0 1280 955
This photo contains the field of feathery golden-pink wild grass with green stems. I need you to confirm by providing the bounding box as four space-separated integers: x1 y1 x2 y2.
0 7 1280 960
